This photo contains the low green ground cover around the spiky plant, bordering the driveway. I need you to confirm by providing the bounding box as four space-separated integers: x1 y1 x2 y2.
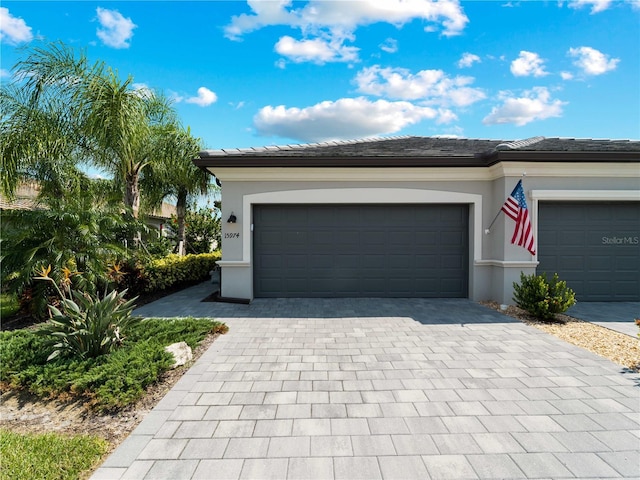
0 318 226 412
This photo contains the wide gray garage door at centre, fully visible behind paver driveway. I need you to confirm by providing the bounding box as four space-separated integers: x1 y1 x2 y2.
253 205 469 297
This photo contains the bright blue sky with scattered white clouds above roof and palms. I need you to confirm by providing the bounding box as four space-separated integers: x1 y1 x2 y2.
0 0 640 149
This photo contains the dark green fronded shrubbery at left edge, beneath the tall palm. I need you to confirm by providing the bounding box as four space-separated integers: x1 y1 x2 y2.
0 179 135 318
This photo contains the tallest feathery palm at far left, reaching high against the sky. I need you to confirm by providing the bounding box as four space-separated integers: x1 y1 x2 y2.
0 42 175 217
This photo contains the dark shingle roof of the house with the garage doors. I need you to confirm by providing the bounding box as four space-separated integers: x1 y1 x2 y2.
194 136 640 168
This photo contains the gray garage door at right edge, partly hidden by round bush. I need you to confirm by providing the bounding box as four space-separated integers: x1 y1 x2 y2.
538 202 640 302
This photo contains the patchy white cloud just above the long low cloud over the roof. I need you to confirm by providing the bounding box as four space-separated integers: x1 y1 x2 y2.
354 65 485 107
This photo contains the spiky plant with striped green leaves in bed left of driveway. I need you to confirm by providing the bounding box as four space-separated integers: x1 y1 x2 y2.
36 266 140 360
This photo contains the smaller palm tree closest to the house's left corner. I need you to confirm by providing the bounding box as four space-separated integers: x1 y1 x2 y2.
143 124 216 255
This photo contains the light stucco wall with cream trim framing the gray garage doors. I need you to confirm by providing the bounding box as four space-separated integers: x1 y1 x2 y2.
213 162 640 303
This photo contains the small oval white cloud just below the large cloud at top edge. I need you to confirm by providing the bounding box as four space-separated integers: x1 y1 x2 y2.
275 36 359 64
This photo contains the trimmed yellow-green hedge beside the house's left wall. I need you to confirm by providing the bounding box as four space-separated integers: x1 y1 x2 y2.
139 252 220 292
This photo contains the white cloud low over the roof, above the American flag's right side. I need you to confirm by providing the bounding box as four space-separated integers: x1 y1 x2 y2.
482 87 566 127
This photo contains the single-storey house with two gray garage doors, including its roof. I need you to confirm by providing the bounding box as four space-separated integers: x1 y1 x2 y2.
194 137 640 303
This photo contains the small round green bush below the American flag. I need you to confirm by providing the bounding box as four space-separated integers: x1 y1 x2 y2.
513 272 576 320
